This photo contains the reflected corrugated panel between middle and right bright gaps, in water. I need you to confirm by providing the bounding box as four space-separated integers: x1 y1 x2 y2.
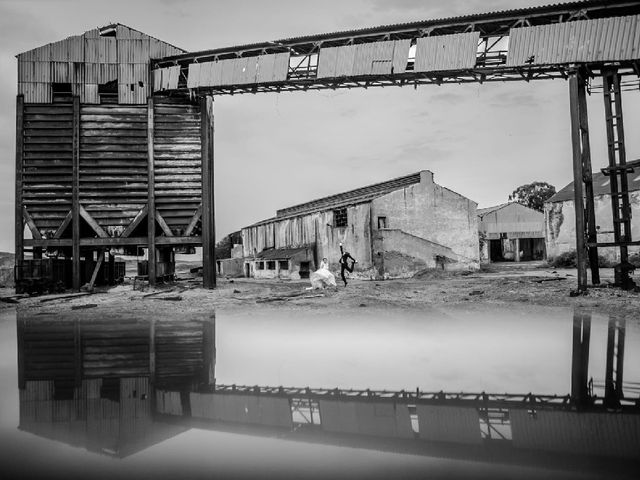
417 405 482 445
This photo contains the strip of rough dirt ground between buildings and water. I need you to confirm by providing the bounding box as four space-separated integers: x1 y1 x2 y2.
5 263 640 318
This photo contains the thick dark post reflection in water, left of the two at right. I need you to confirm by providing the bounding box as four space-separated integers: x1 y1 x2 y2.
571 312 591 407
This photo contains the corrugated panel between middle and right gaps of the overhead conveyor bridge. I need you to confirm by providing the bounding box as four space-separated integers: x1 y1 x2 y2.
414 32 480 72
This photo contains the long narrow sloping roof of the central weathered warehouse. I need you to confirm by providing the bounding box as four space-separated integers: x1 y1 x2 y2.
272 172 428 220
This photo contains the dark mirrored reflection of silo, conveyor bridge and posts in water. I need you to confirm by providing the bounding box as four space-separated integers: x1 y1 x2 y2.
10 311 640 476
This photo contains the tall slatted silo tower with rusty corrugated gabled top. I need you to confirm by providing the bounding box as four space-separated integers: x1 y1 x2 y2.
15 24 215 290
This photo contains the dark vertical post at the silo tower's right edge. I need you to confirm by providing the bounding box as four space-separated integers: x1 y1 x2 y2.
200 96 216 288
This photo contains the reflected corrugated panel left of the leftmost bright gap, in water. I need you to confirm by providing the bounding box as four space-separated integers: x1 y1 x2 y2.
190 393 293 428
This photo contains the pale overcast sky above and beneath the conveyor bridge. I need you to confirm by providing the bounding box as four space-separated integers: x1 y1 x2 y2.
0 0 640 251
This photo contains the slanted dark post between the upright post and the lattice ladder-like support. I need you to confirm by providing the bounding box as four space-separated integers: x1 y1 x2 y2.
578 70 600 285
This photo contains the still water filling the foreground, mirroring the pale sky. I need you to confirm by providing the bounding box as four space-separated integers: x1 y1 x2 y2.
0 306 640 478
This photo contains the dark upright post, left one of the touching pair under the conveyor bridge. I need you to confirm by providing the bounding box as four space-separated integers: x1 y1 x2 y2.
569 72 587 292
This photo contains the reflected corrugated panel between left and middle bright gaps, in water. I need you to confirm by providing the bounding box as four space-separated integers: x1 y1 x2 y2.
320 400 414 438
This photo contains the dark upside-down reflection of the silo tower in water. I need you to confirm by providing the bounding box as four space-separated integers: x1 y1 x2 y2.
18 312 215 457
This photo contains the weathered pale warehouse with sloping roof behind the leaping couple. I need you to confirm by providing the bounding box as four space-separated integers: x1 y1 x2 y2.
242 170 479 279
